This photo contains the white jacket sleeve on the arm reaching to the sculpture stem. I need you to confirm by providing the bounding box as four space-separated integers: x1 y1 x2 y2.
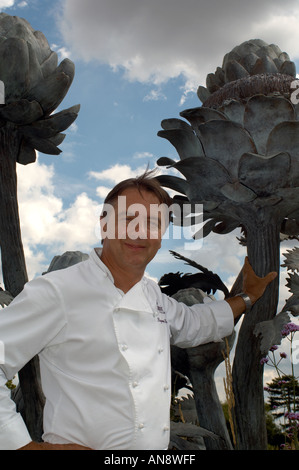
161 288 234 348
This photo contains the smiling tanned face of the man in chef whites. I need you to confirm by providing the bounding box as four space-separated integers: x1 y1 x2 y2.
101 188 166 270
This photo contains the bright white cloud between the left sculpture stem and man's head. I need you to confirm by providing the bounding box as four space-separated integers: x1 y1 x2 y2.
18 157 99 279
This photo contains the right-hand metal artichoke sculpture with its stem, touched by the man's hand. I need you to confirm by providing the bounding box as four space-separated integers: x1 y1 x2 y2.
158 40 299 449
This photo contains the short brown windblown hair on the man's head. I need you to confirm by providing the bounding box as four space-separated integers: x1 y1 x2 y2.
104 170 173 207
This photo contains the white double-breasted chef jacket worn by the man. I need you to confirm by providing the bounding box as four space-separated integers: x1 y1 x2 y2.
0 250 233 450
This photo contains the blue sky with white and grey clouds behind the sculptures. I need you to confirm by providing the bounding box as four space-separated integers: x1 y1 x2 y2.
0 0 299 400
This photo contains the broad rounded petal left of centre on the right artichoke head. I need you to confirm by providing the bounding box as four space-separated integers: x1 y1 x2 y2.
199 120 256 181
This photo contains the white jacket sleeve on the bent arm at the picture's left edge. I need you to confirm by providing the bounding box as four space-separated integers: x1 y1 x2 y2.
0 277 66 450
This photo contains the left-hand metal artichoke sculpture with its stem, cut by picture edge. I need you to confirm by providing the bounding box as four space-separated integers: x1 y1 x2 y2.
0 13 79 439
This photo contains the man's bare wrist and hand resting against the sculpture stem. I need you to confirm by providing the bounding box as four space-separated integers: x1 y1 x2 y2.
226 256 277 319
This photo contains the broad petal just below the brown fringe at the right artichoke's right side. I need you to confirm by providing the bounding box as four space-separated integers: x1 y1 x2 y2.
244 95 295 155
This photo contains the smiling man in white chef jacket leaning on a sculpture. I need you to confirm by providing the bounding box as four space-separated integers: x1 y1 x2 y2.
0 174 276 450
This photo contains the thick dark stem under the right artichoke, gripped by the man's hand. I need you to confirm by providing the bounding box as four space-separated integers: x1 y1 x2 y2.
233 215 280 450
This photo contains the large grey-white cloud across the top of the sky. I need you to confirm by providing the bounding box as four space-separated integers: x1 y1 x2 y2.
61 0 299 94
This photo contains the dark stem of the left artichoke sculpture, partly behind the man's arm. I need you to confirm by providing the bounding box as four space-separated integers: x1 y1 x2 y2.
0 124 44 440
